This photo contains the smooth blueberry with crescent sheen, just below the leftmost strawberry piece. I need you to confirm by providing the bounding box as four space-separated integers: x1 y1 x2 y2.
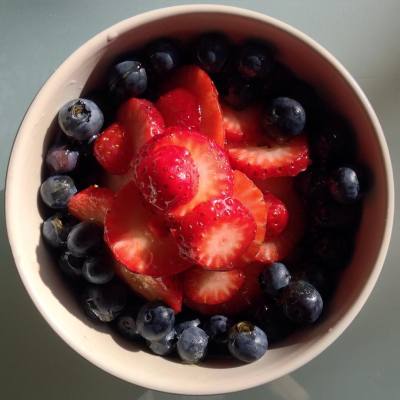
67 221 103 257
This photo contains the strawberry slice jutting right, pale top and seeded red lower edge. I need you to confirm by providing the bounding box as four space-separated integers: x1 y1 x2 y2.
228 136 310 179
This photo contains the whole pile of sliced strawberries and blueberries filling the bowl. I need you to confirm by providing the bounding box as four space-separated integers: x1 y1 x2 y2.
40 33 369 363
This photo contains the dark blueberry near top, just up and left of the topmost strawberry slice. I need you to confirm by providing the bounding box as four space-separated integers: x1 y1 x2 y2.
146 38 181 77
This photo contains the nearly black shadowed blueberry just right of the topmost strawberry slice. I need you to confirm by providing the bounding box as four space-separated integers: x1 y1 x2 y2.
218 74 259 110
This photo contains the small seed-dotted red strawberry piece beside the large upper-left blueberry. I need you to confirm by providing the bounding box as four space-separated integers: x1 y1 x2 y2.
93 123 133 175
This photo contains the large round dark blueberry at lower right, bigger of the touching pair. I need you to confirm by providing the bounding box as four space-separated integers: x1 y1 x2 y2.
281 281 323 324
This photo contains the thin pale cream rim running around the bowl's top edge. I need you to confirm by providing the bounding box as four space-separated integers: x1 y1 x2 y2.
4 4 394 395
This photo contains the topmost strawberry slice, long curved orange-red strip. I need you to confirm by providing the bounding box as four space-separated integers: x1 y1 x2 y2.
167 65 225 146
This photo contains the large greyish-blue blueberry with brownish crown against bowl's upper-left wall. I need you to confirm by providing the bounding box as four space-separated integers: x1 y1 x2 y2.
58 99 104 141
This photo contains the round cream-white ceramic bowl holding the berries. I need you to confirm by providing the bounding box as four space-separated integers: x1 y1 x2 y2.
6 5 394 394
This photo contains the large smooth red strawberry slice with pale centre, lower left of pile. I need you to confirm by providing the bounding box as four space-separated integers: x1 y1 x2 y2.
104 182 190 276
